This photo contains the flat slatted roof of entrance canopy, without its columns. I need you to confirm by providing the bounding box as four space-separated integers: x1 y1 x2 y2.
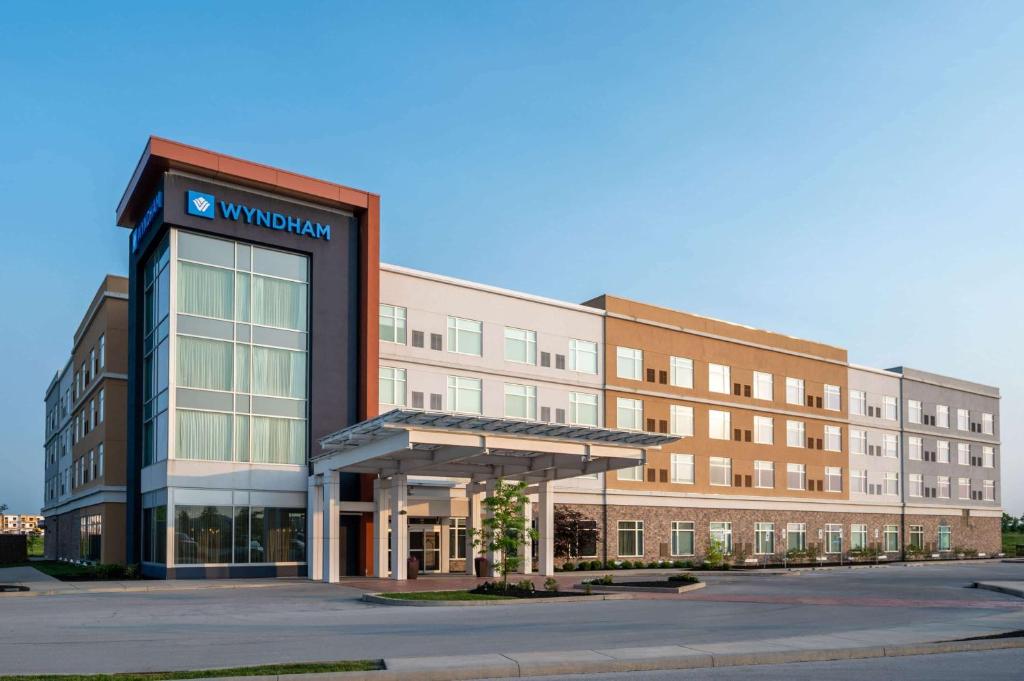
312 409 679 482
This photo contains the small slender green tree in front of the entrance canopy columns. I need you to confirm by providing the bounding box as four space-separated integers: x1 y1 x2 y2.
473 480 537 590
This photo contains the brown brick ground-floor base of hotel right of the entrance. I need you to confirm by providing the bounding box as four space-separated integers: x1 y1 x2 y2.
556 504 1001 564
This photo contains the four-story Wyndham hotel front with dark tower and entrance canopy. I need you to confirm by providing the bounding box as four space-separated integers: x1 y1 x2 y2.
88 138 999 581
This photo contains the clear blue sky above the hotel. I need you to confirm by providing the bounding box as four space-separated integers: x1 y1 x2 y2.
0 1 1024 514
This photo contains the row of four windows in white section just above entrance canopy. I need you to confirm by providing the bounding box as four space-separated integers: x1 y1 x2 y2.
379 367 600 426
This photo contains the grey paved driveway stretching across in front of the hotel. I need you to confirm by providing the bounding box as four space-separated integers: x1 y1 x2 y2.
0 563 1024 673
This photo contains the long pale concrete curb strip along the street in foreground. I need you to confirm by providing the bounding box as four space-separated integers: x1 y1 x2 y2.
140 638 1024 681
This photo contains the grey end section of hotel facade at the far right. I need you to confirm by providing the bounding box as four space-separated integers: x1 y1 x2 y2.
893 367 1000 553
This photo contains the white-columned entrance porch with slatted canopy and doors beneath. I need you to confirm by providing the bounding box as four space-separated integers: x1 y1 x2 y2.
307 410 677 582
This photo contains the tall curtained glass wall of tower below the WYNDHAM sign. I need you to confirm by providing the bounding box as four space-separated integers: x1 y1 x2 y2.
165 230 309 464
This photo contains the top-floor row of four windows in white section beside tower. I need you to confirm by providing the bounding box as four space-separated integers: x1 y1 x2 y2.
380 303 598 374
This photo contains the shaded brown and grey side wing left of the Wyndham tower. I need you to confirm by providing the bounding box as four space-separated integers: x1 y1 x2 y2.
43 275 128 563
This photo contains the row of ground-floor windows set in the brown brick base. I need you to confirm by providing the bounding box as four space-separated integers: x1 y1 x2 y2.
606 520 952 558
